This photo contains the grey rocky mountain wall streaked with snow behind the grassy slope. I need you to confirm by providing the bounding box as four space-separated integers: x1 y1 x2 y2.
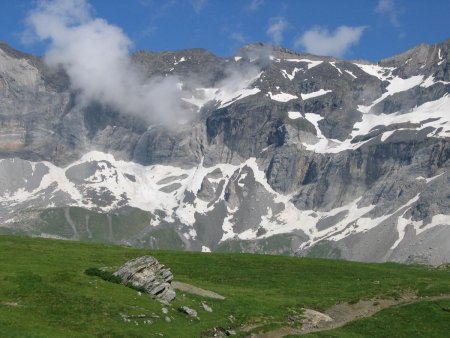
0 40 450 264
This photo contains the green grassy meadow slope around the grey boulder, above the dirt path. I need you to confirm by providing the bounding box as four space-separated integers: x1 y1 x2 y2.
0 236 450 337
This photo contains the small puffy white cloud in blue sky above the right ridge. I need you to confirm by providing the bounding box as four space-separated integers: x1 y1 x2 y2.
295 26 366 57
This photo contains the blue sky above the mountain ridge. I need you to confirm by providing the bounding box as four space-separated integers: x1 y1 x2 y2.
0 0 450 61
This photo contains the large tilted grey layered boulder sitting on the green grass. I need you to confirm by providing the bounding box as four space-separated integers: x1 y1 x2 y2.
114 256 176 302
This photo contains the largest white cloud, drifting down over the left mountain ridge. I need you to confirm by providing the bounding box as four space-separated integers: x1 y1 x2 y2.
26 0 192 125
